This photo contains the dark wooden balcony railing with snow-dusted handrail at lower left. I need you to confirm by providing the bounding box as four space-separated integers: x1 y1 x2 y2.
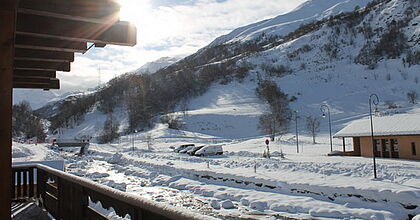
11 164 206 220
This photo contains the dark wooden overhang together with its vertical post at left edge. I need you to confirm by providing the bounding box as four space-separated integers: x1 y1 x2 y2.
0 0 136 219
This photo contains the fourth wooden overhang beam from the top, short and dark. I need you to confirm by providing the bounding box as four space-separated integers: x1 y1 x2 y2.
15 49 74 62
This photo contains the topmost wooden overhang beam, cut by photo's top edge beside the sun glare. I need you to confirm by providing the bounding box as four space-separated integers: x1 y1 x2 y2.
19 0 121 20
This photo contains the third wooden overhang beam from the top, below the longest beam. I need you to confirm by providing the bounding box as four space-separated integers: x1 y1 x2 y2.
15 34 87 53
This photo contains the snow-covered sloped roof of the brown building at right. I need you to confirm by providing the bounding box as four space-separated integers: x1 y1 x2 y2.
334 114 420 138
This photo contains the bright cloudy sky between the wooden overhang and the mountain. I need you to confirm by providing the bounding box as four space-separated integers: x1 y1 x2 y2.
58 0 305 92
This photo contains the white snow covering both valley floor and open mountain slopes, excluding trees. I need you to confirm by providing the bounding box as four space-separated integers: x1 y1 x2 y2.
13 0 420 219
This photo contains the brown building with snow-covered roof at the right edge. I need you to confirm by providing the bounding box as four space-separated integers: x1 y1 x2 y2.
334 114 420 160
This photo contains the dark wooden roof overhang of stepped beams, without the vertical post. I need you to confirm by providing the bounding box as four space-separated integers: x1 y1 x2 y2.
13 0 136 89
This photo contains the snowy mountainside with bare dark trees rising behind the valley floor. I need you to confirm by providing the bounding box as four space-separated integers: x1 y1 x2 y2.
39 0 420 141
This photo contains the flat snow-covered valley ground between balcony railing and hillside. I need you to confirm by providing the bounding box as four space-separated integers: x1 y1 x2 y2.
13 128 420 219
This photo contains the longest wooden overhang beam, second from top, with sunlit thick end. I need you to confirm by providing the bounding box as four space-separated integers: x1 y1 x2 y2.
16 14 137 46
